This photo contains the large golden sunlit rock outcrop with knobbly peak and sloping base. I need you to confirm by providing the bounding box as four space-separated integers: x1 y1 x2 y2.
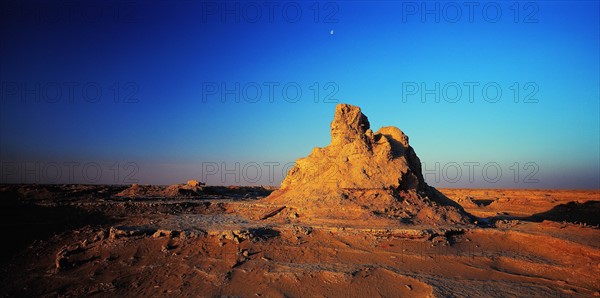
265 104 470 224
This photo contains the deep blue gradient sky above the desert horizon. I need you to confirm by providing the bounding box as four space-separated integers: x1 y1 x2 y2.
0 1 600 189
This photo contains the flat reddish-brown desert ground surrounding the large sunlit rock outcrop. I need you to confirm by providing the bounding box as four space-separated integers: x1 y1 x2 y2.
0 185 600 297
